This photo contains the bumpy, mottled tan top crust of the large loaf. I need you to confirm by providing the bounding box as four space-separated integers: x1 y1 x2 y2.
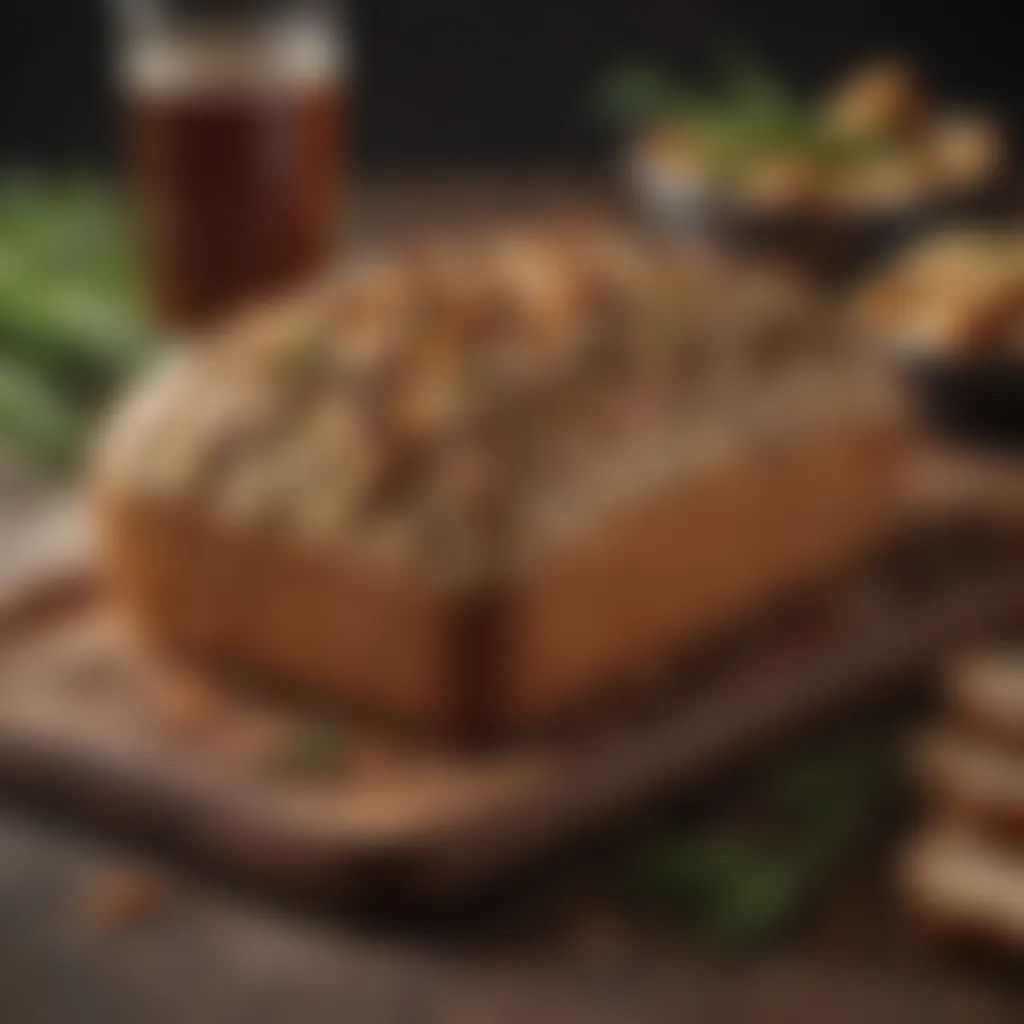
102 218 888 575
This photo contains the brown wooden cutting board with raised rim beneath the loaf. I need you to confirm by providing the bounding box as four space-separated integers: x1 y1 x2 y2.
0 456 1024 903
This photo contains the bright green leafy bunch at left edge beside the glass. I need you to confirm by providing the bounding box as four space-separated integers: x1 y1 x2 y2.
0 171 150 465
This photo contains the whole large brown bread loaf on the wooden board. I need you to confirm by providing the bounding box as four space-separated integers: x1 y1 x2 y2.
95 226 902 730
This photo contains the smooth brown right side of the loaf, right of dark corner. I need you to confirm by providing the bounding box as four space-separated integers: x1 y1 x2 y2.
503 411 901 723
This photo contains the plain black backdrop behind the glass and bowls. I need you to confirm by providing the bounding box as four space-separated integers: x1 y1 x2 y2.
0 0 1024 170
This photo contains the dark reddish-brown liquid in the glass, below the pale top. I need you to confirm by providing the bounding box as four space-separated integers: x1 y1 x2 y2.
131 81 345 327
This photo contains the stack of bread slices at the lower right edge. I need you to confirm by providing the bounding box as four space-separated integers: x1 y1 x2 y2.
902 650 1024 955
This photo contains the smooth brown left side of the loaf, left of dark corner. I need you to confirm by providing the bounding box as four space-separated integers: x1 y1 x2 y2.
98 497 460 728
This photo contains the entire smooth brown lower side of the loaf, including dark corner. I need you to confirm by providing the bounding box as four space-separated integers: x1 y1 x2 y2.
96 395 902 731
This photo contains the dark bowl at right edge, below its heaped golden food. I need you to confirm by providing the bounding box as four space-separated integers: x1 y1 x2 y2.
900 356 1024 452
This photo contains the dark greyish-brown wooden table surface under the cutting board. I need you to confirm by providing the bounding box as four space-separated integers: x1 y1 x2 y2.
6 178 1024 1024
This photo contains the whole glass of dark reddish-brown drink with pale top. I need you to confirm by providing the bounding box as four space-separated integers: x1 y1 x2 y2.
110 0 347 328
